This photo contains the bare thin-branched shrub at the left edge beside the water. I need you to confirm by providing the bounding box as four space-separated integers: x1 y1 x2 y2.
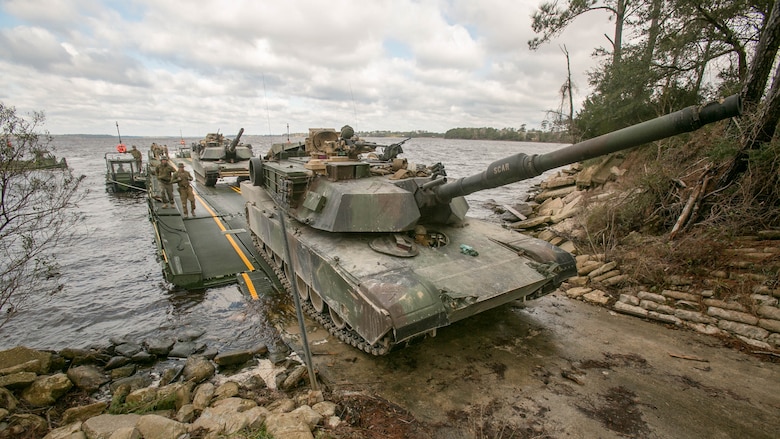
0 102 84 328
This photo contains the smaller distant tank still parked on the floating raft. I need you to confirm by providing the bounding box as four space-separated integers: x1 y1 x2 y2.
192 128 253 186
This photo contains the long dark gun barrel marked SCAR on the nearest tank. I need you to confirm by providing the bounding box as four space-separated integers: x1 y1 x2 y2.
432 94 742 204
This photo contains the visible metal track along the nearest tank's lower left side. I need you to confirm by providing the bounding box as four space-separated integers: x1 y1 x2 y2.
252 232 393 356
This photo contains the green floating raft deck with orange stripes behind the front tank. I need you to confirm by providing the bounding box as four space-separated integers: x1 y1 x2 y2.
147 154 281 300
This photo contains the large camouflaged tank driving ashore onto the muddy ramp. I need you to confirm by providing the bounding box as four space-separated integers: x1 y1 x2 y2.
241 95 741 355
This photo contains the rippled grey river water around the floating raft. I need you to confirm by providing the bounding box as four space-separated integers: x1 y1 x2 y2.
0 135 561 350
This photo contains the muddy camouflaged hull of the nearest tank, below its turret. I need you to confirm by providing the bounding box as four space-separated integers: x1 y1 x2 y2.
241 182 576 355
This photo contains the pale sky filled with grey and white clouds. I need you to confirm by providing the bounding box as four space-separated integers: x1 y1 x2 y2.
0 0 614 137
